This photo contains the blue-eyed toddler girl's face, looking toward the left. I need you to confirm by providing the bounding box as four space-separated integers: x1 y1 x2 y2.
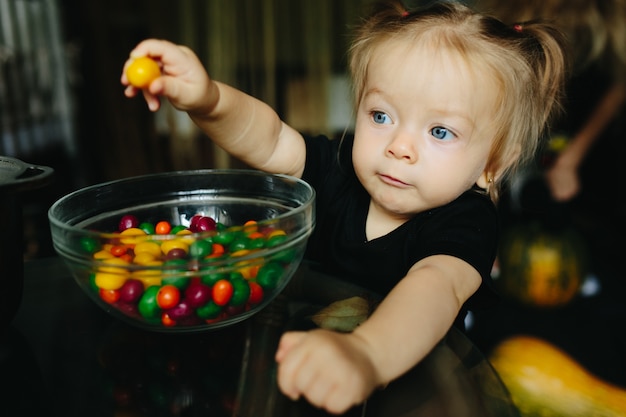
353 41 497 219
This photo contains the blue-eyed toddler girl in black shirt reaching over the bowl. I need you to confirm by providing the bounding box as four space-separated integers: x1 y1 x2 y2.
122 2 565 413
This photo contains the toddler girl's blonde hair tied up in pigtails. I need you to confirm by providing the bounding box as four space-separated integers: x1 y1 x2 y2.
349 1 566 201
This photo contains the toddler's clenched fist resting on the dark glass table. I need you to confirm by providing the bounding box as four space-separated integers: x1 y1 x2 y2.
276 329 381 414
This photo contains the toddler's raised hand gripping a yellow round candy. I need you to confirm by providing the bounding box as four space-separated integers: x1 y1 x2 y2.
121 39 219 114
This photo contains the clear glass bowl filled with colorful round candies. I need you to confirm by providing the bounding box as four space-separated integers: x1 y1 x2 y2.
48 169 315 332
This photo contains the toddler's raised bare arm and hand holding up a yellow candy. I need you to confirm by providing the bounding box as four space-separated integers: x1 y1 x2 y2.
121 39 306 177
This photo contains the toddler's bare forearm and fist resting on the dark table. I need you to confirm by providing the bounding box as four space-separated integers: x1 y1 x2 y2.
276 255 481 413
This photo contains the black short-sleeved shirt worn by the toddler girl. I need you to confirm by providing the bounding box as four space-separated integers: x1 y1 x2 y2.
302 136 498 320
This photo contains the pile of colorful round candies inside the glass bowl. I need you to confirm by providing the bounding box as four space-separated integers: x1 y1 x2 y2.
81 214 294 327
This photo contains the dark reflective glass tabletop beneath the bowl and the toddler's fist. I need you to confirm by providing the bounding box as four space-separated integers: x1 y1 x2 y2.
0 258 518 417
